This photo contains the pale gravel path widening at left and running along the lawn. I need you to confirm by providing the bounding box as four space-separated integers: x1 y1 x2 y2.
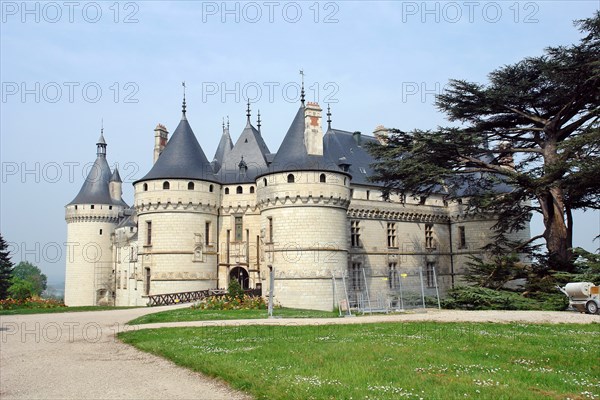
0 304 600 400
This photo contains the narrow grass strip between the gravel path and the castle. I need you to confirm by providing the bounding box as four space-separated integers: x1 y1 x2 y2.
128 308 339 325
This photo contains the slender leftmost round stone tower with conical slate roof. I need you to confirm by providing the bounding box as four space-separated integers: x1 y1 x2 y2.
65 132 126 306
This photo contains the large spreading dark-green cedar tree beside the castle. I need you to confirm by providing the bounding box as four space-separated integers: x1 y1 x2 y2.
369 12 600 271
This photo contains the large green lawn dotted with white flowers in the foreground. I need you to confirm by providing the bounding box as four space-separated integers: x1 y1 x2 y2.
119 321 600 399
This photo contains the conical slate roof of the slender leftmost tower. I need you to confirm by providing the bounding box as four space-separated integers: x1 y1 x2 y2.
67 147 113 205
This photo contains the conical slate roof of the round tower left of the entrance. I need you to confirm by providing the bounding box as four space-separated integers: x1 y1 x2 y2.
134 112 216 184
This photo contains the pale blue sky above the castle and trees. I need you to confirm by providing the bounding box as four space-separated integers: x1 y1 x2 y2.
0 0 600 284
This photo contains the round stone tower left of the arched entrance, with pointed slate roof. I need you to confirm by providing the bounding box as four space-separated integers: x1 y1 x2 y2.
134 98 221 296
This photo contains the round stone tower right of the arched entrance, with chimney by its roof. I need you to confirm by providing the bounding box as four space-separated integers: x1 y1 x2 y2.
256 102 350 310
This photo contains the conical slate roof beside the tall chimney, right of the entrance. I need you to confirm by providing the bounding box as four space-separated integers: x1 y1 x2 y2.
270 105 340 172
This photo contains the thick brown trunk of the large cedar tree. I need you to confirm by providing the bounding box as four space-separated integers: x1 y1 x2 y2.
539 187 573 272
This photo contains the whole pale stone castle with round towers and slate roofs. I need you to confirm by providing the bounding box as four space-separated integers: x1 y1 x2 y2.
65 95 529 310
